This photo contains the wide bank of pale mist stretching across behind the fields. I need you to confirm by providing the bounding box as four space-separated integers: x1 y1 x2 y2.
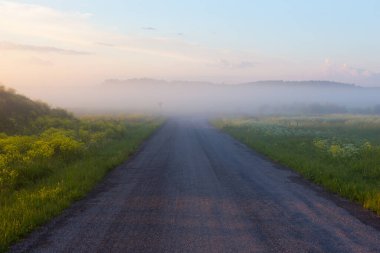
17 79 380 115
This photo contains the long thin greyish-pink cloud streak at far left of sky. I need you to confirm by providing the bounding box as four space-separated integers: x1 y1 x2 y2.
0 41 91 55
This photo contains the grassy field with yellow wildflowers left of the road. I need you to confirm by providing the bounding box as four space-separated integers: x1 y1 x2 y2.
0 117 162 252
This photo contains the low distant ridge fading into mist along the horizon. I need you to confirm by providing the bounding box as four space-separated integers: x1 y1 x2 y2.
100 79 380 113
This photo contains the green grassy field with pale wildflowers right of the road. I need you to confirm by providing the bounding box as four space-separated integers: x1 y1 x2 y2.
212 115 380 214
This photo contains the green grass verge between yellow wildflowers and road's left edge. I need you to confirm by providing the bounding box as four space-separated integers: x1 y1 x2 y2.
0 117 161 252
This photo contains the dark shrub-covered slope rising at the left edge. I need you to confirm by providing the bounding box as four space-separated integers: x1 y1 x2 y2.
0 86 73 134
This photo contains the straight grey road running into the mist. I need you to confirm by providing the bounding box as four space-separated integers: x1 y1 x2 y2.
11 119 380 253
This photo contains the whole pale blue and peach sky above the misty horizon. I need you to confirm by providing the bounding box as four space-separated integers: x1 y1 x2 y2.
0 0 380 90
